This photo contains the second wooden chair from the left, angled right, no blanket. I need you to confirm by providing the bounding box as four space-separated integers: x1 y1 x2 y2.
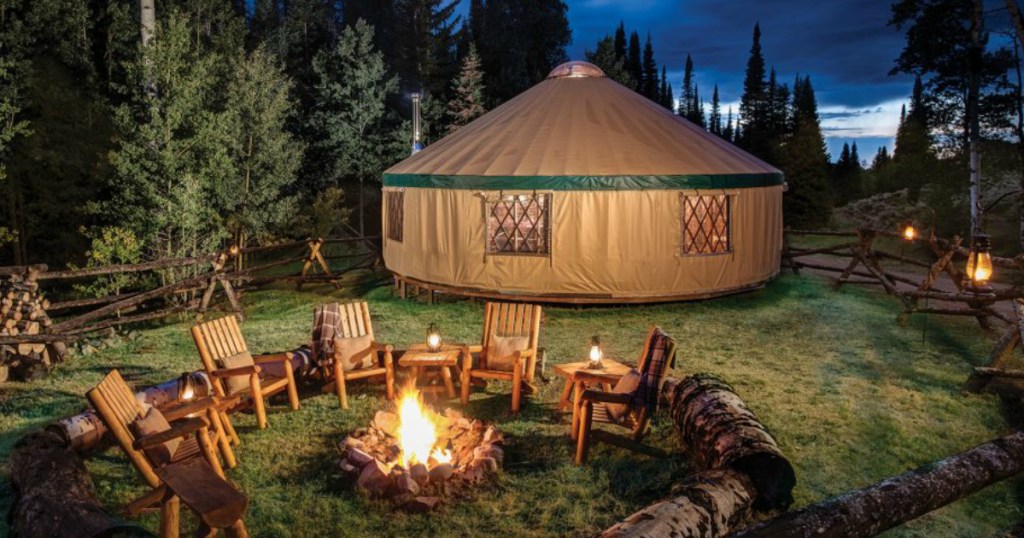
191 316 299 429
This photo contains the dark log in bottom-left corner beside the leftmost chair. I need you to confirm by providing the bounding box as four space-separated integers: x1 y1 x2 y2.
9 430 152 538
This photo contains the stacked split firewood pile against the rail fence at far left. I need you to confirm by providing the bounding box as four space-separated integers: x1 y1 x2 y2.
0 271 68 381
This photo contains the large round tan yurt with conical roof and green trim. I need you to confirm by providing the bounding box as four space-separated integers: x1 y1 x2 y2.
382 61 784 303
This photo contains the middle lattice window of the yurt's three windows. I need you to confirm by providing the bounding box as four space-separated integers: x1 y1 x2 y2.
487 194 551 256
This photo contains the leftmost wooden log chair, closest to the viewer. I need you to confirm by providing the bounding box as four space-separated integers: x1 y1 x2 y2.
86 370 249 537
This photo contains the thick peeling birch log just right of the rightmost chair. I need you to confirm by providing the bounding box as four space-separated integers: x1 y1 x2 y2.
662 374 797 509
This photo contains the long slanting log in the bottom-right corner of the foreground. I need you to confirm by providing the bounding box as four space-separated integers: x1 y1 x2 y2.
731 431 1024 538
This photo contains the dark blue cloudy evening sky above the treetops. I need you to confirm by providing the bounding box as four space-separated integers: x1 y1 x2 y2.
462 0 913 161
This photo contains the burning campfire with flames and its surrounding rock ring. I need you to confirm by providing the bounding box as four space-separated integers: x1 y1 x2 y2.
339 389 505 511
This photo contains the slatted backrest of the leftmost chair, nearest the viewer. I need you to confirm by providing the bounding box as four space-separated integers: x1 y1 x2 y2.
86 370 160 488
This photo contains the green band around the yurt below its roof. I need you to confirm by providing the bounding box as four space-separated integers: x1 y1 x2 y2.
384 173 784 191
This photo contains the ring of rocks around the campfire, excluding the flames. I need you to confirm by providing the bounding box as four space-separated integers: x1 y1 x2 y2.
338 409 505 513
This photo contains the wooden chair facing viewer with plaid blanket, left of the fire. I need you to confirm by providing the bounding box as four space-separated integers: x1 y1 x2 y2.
321 301 394 409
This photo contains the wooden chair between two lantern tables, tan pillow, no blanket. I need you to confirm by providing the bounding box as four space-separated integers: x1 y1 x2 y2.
462 302 541 413
